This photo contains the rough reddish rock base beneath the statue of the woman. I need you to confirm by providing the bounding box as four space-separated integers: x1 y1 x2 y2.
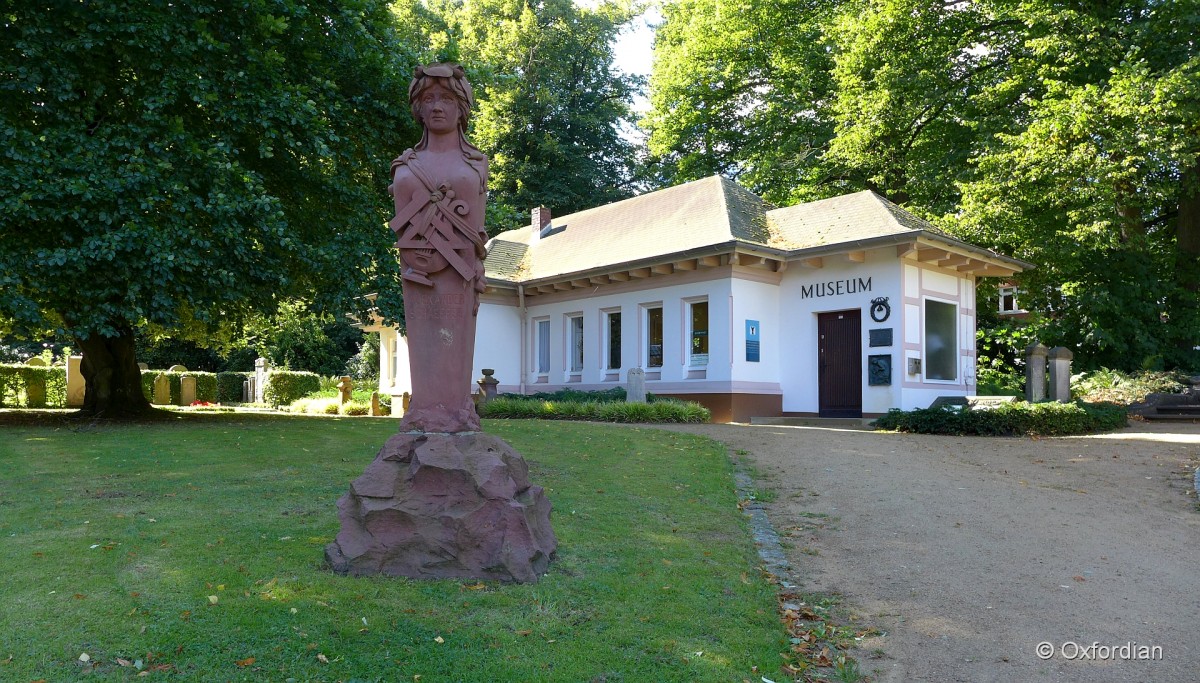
325 432 558 583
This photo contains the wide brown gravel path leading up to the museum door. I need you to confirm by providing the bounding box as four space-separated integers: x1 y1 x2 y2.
657 423 1200 683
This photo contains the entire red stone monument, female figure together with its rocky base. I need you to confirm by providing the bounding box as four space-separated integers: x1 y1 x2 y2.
325 64 557 582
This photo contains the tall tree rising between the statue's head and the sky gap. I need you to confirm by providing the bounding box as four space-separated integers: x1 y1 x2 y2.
431 0 640 232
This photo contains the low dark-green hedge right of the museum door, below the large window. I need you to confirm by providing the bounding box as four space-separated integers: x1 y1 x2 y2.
875 401 1129 436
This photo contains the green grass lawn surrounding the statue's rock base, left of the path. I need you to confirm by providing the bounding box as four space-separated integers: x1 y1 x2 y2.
0 414 786 683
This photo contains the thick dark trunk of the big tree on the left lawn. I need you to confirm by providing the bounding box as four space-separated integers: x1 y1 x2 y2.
76 328 151 418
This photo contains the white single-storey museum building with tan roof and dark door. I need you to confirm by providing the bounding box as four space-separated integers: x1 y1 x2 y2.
367 176 1031 423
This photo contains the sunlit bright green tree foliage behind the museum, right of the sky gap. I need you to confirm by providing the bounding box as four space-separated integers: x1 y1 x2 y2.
647 0 1200 366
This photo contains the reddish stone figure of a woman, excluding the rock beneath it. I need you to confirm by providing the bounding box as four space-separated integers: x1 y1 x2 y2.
389 64 487 432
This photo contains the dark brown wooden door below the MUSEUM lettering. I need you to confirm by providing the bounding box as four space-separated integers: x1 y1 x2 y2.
817 310 863 418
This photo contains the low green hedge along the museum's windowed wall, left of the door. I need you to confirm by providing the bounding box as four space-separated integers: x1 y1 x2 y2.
480 396 713 423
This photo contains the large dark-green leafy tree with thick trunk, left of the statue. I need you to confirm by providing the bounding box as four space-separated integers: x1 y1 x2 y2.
0 0 416 414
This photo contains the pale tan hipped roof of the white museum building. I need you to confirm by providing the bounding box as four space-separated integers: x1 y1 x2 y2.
485 175 1019 282
